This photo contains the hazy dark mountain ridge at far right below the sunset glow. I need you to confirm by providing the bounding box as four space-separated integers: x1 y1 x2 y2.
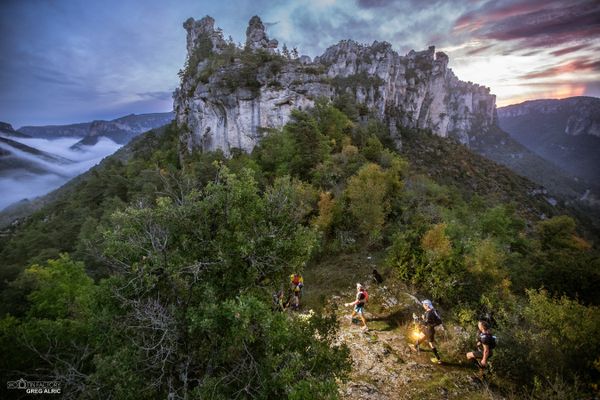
498 97 600 186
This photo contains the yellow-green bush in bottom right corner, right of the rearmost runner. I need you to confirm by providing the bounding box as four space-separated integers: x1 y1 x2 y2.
494 290 600 398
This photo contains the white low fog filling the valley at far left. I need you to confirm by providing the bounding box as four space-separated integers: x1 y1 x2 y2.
0 138 121 210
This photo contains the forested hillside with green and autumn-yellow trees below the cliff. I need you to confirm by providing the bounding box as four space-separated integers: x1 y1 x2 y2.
0 101 600 399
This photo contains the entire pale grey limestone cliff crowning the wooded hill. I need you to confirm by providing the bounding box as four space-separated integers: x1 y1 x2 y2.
174 17 495 153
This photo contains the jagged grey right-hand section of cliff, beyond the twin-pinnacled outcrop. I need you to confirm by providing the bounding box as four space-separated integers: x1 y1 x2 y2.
315 41 496 144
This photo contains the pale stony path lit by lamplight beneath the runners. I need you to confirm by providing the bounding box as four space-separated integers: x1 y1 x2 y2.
330 288 502 400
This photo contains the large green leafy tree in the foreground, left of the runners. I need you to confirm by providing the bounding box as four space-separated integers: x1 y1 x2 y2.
95 167 348 398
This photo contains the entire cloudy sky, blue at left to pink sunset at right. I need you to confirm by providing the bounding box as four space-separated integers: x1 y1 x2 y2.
0 0 600 128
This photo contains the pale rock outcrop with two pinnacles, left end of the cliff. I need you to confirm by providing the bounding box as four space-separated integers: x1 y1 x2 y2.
174 17 333 153
